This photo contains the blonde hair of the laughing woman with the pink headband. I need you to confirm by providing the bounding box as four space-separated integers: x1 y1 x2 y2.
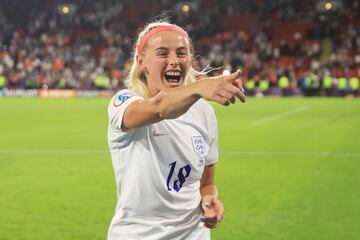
125 20 203 98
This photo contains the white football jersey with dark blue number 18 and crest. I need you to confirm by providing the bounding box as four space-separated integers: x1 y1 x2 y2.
108 90 218 240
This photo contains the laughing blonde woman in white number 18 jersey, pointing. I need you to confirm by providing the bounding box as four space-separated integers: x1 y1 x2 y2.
108 22 245 240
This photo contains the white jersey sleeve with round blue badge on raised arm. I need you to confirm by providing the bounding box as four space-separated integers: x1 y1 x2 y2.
108 89 143 131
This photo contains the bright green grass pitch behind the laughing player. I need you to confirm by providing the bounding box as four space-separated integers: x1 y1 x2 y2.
0 98 360 240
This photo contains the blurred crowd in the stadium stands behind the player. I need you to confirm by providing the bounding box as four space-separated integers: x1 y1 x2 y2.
0 0 360 96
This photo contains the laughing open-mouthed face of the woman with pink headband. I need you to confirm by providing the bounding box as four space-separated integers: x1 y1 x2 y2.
138 31 191 96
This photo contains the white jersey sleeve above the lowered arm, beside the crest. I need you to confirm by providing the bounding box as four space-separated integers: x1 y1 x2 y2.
205 106 219 165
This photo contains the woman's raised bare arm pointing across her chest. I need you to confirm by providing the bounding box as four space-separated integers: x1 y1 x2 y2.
121 71 245 129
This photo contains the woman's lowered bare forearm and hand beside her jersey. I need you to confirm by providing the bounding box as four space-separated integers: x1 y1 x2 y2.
200 164 224 228
